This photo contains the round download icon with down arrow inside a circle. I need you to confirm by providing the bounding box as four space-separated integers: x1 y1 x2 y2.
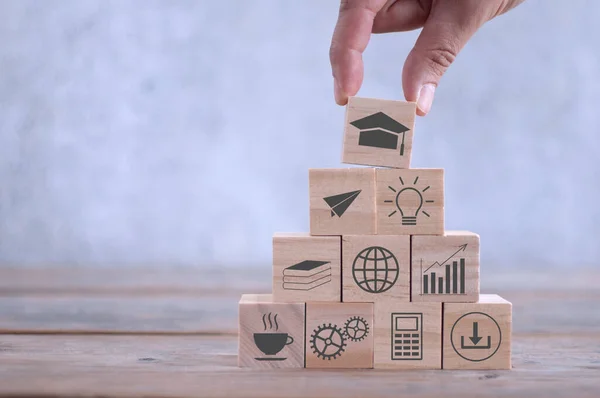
450 312 502 362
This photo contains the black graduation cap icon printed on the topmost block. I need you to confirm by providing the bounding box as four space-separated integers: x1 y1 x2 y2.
350 112 410 156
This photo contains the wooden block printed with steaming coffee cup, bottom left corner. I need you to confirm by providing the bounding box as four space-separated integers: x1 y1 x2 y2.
238 294 306 369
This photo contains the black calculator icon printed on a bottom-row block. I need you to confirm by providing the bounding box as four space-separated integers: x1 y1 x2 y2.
391 312 423 361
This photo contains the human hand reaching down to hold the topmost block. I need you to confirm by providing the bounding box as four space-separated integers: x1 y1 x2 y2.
329 0 524 116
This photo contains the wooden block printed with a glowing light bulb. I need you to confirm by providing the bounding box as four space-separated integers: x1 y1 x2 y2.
376 169 444 235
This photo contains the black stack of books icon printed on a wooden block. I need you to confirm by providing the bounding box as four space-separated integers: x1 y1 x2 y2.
283 260 331 291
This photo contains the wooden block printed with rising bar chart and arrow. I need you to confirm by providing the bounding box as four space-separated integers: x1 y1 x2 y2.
412 231 479 303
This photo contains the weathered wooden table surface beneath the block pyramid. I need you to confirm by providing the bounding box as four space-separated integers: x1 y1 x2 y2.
0 267 600 398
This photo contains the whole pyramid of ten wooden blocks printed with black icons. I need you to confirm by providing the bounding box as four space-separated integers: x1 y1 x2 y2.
238 97 512 370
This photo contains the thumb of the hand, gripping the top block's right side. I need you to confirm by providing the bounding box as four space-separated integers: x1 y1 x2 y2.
402 8 484 116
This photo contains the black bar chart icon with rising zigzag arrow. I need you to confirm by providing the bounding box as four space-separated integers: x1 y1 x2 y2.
421 243 467 295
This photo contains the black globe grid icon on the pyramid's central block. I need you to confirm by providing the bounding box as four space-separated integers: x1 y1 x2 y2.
352 246 399 293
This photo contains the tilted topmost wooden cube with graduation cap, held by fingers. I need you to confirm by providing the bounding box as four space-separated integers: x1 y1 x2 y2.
342 97 417 169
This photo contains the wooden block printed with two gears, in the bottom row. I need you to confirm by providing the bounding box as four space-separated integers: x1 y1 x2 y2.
306 302 373 369
